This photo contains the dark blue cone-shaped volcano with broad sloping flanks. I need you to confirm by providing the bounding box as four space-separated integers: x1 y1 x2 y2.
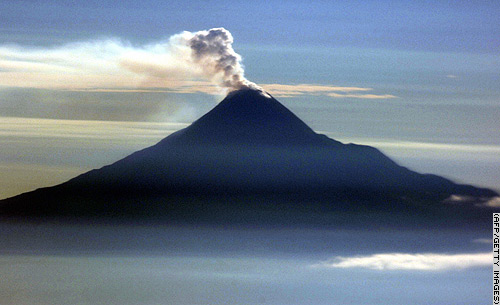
0 89 498 223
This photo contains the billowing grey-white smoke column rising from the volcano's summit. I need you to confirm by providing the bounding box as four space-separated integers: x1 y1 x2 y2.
171 28 263 91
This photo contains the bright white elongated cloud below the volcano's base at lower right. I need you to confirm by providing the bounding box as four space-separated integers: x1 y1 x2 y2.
314 252 493 271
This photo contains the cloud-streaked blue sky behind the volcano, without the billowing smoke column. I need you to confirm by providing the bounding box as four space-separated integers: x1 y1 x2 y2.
0 0 500 198
